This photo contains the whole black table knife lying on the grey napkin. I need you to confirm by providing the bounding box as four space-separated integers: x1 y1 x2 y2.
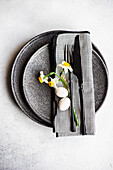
73 35 86 135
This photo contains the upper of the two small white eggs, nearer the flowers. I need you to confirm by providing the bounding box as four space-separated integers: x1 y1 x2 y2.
55 87 68 98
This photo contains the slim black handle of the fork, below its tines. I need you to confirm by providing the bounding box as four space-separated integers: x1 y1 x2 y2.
70 73 76 132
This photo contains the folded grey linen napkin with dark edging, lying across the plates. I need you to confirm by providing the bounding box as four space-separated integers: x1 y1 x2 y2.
54 33 95 136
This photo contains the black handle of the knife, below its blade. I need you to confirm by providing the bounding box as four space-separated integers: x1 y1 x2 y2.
79 84 86 135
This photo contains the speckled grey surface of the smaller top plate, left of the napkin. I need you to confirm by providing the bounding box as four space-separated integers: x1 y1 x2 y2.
23 44 51 124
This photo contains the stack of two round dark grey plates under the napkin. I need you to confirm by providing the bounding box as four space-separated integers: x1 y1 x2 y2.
11 30 108 127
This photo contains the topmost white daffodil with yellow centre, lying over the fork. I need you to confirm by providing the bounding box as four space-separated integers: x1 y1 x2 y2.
57 61 73 74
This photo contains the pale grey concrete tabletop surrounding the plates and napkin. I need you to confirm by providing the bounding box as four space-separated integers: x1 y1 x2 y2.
0 0 113 170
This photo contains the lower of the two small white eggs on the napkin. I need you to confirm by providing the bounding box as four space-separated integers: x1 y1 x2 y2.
58 97 70 111
